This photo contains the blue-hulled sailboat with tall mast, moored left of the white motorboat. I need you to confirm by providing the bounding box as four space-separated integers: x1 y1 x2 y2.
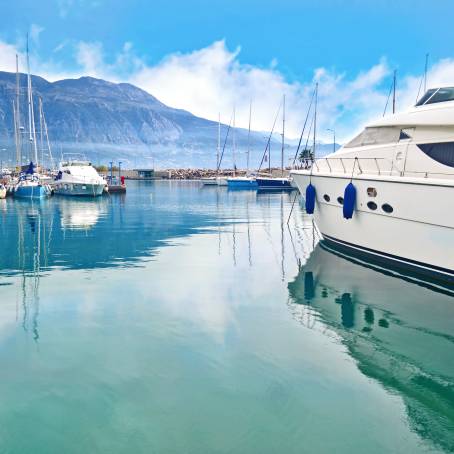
13 40 52 199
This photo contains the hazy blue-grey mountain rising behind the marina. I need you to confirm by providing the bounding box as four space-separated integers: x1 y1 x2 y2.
0 72 332 167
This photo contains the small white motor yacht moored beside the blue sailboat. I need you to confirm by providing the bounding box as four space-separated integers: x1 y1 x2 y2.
53 160 107 197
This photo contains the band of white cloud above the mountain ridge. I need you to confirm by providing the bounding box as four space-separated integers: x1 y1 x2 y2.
0 36 454 141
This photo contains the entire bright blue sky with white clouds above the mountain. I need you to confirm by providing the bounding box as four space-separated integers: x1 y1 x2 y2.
0 0 454 142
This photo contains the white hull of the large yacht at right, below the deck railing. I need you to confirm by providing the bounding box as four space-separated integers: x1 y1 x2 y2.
293 173 454 285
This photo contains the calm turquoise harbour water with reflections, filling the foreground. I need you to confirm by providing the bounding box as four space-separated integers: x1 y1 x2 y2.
0 182 454 454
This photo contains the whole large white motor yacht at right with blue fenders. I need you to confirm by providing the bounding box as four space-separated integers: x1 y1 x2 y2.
292 87 454 284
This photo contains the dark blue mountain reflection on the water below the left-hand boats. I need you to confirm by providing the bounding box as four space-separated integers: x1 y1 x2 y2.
0 186 213 276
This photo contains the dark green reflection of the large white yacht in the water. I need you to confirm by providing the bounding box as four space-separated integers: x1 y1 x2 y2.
288 244 454 452
